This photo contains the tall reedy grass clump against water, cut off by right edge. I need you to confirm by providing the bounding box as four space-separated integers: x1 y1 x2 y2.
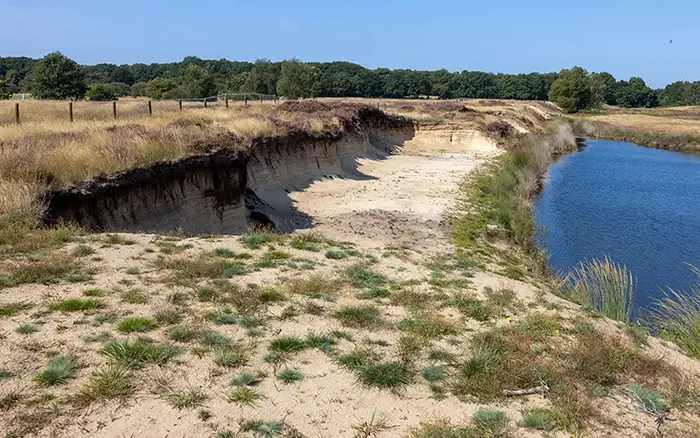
652 286 700 358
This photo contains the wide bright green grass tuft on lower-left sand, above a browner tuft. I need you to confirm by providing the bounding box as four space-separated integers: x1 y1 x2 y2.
102 339 180 368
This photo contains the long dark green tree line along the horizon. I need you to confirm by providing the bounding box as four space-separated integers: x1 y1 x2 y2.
0 52 700 109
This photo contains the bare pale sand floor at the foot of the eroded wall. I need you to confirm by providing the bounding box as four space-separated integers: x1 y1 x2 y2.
290 132 499 251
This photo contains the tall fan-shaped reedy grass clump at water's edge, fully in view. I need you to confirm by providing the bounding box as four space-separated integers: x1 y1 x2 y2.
562 256 635 323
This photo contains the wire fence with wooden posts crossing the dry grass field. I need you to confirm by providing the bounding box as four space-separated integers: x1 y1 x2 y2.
0 93 278 125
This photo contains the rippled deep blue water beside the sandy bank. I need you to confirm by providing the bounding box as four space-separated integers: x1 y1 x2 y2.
534 140 700 310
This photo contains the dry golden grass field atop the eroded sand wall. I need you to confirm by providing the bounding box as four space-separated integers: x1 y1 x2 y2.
0 100 388 219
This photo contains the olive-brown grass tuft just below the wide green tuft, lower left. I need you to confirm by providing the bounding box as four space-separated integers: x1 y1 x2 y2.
72 364 136 407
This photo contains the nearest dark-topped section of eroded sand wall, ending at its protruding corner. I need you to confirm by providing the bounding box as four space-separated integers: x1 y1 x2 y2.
45 150 247 234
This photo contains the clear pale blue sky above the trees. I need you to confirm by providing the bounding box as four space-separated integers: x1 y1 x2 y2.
0 0 700 87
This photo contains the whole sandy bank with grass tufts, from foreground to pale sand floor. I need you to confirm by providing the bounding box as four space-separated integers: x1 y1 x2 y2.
0 102 700 438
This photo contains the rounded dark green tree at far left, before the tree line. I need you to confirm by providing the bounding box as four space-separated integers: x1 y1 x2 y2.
32 52 87 99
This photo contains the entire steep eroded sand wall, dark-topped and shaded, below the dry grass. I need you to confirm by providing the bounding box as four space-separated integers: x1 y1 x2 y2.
44 115 414 235
